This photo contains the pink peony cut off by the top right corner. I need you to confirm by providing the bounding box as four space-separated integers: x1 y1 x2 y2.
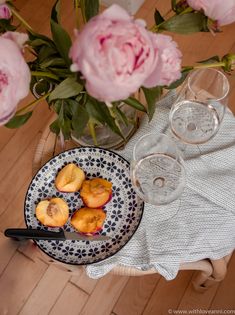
187 0 235 26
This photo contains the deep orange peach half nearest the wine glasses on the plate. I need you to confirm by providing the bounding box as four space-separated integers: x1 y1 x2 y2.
80 178 112 208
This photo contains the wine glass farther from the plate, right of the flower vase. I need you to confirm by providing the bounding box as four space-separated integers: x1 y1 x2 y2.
169 68 229 144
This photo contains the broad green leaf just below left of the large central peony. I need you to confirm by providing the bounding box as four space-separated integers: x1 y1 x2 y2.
49 77 83 103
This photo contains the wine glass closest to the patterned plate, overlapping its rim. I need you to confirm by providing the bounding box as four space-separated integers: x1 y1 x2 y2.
131 133 186 205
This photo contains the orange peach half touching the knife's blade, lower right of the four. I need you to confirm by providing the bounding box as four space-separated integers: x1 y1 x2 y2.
70 208 106 234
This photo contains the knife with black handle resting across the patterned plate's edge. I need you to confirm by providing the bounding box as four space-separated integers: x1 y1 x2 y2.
4 228 110 242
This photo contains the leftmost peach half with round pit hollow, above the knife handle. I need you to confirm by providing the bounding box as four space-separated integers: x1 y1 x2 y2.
36 198 69 227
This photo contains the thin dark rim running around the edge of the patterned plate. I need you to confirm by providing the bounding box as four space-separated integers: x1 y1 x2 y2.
24 146 145 266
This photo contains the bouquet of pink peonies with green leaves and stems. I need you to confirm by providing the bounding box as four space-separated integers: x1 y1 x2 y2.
0 0 235 144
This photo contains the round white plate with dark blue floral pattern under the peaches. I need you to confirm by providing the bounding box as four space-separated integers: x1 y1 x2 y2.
25 147 144 265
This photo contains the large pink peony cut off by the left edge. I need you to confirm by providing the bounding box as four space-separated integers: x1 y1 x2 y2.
0 32 31 125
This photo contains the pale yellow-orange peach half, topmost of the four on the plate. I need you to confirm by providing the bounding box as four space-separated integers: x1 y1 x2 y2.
55 163 85 192
